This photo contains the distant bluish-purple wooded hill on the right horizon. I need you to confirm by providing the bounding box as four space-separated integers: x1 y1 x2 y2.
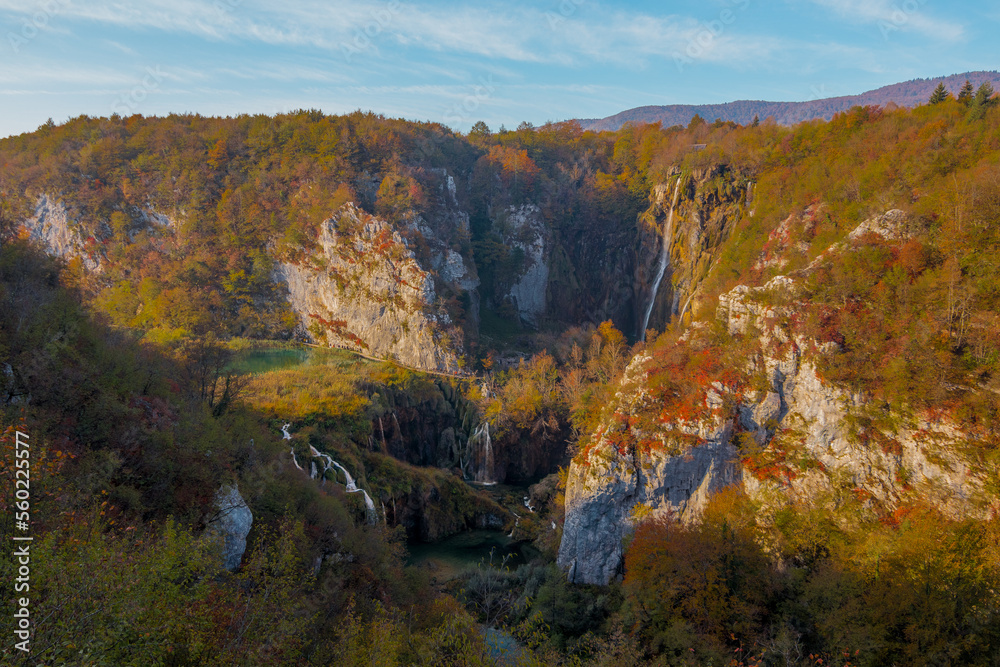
579 71 1000 131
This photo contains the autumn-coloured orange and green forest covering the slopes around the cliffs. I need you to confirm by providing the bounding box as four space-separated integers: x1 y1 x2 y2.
0 89 1000 665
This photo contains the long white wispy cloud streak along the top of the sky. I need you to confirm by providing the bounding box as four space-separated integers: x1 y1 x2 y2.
0 0 774 66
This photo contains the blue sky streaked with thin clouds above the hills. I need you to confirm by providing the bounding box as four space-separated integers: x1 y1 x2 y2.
0 0 1000 136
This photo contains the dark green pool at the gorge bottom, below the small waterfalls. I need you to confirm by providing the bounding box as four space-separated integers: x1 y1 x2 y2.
407 530 532 581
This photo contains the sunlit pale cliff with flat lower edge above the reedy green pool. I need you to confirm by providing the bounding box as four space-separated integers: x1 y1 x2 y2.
274 204 468 372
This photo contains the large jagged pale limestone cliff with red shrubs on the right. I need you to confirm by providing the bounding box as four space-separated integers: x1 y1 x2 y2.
558 212 996 584
